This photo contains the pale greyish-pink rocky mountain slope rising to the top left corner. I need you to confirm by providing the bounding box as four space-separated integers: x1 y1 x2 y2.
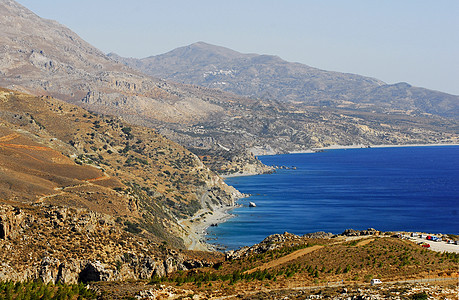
0 0 230 121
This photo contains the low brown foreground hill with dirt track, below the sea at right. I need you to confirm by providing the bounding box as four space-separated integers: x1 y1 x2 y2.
90 229 459 299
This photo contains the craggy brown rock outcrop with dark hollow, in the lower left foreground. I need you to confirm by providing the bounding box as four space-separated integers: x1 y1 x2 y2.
0 205 216 283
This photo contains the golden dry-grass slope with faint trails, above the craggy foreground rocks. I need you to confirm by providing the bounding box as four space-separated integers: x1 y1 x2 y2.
0 89 237 247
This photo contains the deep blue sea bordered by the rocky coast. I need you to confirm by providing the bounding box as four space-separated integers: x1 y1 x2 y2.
208 146 459 249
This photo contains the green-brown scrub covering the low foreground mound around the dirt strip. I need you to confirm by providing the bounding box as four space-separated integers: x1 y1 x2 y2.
151 237 459 290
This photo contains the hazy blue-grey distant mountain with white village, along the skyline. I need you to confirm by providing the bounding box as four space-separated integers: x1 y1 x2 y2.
109 42 459 118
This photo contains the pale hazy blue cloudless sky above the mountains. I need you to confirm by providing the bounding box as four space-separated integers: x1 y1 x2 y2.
18 0 459 95
